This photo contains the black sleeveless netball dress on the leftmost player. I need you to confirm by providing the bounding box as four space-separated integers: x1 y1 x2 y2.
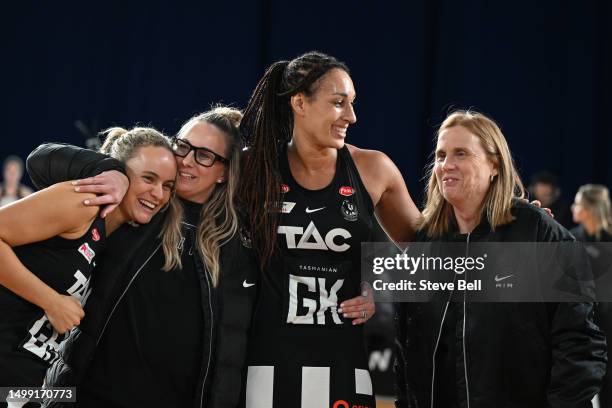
0 217 106 387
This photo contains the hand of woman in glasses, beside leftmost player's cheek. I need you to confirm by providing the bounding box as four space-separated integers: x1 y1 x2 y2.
72 170 130 218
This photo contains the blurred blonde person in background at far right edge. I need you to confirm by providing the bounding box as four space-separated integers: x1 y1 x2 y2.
572 184 612 408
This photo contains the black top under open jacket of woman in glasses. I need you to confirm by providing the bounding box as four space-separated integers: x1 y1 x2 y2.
77 200 209 407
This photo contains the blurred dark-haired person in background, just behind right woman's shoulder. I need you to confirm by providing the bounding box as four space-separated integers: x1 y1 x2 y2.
529 171 574 229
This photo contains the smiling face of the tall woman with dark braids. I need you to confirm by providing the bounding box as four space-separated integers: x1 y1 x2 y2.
292 69 357 149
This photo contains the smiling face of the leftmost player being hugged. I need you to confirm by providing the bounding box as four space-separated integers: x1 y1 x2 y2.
119 146 176 224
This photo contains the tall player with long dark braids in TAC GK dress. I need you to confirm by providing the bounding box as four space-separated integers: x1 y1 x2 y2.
240 52 420 408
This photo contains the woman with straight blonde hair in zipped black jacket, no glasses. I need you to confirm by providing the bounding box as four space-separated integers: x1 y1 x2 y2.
396 111 606 408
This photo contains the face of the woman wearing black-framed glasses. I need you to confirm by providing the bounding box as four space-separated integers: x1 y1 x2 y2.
176 122 228 204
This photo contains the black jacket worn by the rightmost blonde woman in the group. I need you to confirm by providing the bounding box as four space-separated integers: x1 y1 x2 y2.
395 202 607 408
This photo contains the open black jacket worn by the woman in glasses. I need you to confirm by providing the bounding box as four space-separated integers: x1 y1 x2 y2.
27 144 257 408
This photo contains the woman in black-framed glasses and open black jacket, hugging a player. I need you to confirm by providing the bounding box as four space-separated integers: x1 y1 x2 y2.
28 107 257 408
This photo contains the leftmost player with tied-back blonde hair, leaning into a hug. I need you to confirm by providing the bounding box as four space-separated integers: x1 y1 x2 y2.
0 128 177 396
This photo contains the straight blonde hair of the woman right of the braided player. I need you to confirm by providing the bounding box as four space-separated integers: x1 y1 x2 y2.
420 110 525 238
